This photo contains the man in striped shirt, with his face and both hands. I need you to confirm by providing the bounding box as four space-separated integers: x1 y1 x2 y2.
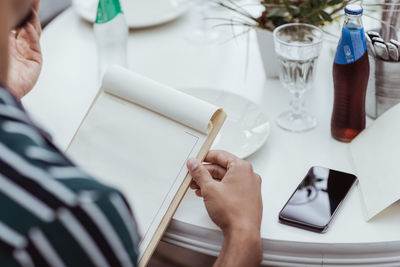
0 0 262 267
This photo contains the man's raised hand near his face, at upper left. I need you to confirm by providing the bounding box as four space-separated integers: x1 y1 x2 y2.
6 0 42 99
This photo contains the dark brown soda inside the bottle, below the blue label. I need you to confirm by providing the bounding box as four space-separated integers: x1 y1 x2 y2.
331 51 369 142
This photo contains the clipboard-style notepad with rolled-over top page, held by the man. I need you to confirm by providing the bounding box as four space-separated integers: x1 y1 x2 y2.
68 66 226 266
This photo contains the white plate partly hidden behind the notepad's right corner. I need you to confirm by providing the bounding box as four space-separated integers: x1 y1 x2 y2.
182 89 270 159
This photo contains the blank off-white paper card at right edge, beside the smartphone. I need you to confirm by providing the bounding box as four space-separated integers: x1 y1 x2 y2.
350 102 400 220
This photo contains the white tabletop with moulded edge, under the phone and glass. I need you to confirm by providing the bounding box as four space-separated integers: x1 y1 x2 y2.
23 6 400 266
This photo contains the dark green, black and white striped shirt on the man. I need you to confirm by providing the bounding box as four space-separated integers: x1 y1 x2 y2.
0 87 139 267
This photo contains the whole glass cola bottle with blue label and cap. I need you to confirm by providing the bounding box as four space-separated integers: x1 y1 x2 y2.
331 4 369 142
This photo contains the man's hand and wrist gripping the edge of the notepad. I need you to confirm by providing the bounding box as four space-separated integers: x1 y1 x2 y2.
187 151 262 266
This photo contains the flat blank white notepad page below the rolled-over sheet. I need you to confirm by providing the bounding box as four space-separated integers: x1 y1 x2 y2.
68 93 207 260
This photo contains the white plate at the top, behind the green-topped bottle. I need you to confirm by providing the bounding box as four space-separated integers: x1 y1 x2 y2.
72 0 189 28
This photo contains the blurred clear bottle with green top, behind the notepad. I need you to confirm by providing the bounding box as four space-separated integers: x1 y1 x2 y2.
94 0 129 82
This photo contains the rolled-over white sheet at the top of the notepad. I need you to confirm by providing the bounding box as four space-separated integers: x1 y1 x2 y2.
103 66 218 133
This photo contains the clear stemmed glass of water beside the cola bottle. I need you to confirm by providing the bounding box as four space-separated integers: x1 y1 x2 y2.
273 23 323 132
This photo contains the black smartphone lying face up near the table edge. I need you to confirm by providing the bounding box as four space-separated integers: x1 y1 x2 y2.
279 167 357 233
